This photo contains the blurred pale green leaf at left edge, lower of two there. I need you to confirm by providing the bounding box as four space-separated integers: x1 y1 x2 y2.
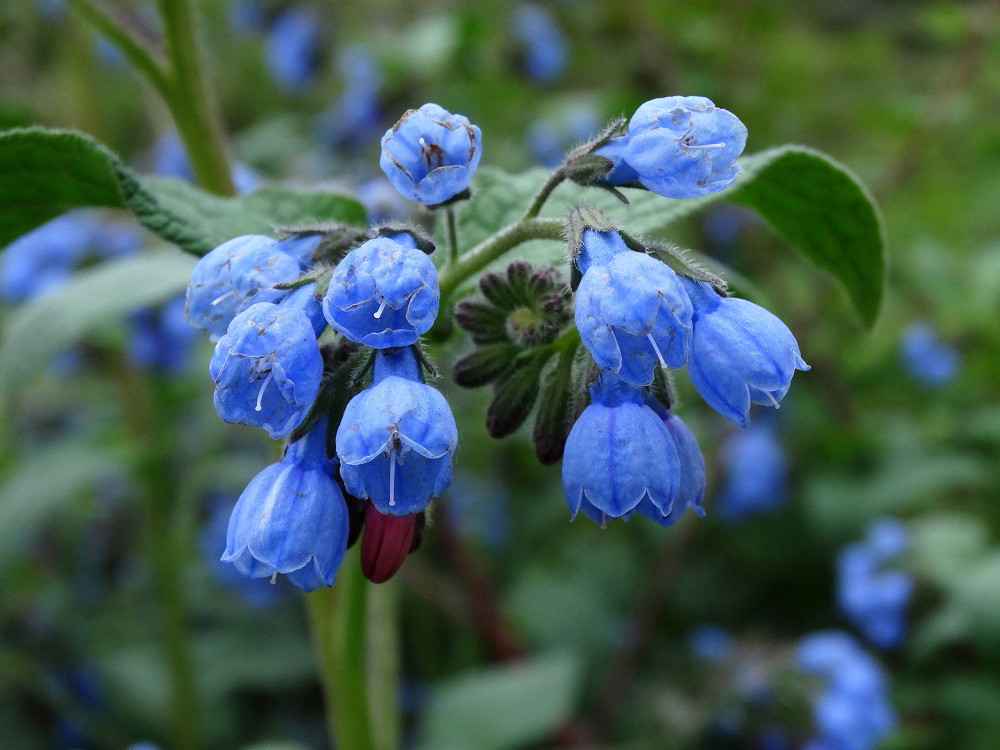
0 441 121 565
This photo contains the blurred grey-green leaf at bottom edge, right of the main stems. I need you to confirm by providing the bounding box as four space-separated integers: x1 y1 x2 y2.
419 654 580 750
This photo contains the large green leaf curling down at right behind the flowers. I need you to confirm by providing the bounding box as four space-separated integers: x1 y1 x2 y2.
458 146 886 327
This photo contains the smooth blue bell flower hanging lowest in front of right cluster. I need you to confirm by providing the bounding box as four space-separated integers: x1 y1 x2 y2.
562 373 681 525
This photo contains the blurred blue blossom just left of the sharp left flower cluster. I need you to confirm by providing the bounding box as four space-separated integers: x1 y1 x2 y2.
128 296 198 373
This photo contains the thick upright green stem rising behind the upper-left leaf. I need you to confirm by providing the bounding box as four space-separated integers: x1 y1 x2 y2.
158 0 236 195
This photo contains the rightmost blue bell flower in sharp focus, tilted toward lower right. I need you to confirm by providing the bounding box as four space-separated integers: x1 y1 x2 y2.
683 277 809 428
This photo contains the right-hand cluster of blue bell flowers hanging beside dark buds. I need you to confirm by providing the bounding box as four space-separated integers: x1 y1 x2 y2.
563 224 808 525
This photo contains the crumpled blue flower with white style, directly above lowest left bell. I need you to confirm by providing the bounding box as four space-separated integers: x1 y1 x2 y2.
209 302 323 438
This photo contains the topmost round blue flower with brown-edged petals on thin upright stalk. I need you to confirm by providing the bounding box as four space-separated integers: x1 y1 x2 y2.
379 104 483 206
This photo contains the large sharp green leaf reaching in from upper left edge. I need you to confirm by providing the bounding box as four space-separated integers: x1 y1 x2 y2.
0 128 365 255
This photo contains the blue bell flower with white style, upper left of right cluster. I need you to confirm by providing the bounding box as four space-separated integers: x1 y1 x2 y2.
574 251 692 385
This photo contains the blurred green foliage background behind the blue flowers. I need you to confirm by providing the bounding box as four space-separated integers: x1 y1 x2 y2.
0 0 1000 749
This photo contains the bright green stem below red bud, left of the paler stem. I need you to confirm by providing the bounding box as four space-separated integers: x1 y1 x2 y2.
306 545 378 750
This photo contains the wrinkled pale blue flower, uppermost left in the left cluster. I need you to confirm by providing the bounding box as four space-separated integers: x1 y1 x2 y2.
186 234 301 336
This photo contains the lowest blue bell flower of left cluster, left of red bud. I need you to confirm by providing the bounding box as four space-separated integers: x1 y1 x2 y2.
222 420 348 591
